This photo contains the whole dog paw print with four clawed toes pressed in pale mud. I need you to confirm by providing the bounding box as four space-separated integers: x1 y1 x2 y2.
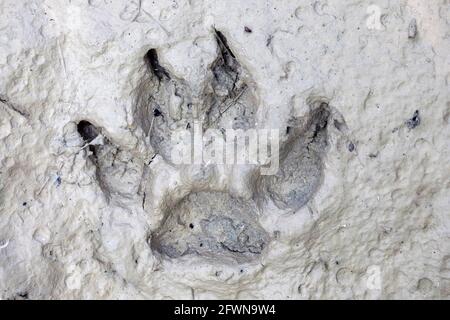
68 30 340 263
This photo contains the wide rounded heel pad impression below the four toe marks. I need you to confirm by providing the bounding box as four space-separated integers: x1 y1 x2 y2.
151 192 268 262
